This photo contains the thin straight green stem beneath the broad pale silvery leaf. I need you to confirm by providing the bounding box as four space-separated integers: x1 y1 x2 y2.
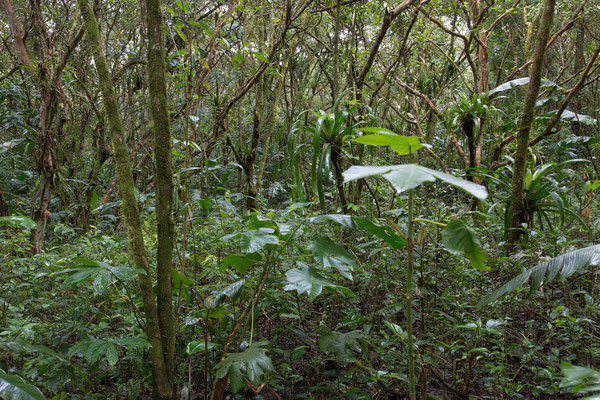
405 189 417 400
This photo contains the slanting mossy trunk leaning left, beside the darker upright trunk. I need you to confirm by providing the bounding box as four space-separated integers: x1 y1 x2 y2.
78 0 173 399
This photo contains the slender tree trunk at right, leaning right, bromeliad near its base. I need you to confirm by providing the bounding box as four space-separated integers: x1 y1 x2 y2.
507 0 556 249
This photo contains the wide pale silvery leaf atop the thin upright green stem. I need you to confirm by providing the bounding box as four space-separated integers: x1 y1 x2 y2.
344 164 487 200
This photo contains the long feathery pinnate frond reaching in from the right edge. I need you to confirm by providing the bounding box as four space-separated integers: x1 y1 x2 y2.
478 245 600 306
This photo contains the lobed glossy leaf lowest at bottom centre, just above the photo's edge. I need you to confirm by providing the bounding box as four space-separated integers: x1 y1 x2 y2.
215 341 275 393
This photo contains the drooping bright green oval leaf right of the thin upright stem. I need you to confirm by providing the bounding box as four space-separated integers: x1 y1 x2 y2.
442 220 490 271
